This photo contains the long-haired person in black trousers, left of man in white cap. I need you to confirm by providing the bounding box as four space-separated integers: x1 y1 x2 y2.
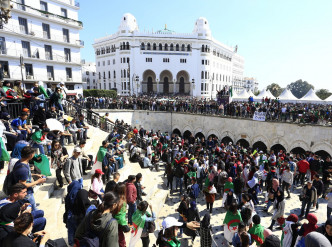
51 140 69 188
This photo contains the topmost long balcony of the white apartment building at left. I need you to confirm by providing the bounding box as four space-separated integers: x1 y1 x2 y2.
12 2 83 29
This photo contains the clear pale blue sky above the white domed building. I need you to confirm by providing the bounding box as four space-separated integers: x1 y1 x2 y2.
79 0 332 91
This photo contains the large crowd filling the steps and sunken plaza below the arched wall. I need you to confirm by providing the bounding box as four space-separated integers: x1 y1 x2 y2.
0 80 332 247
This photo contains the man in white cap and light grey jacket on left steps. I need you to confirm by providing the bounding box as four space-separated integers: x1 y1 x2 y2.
64 147 83 187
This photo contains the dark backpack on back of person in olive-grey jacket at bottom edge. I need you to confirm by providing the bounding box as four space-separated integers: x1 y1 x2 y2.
75 210 115 247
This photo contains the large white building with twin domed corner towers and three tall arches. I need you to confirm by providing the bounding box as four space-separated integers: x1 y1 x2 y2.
93 14 244 98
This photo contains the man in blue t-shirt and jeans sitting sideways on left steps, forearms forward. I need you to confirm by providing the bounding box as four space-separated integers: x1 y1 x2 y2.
13 146 46 211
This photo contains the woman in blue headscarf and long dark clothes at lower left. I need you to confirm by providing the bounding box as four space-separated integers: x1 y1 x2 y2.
63 180 82 246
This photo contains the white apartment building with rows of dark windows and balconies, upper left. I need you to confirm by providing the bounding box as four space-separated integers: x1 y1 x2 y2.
0 0 84 94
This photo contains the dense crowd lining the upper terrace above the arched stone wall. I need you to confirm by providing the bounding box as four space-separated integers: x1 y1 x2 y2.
80 96 332 124
